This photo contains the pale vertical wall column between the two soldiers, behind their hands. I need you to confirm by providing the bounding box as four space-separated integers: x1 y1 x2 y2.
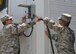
35 0 45 54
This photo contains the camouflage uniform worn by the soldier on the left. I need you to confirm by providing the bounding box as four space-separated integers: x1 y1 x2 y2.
0 14 34 54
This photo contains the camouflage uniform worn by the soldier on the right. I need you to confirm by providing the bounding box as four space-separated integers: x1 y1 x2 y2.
44 13 75 54
